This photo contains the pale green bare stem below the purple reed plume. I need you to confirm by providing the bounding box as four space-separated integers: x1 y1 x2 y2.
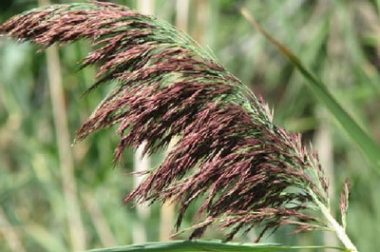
309 189 358 252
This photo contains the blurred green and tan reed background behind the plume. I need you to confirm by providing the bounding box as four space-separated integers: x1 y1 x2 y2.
0 0 380 252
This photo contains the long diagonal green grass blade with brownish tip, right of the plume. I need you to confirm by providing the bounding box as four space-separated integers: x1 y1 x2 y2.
241 8 380 172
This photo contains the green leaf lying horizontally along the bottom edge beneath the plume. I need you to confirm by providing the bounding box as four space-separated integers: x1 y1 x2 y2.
91 240 345 252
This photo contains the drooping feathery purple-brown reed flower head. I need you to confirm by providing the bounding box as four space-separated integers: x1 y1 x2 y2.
0 2 327 239
